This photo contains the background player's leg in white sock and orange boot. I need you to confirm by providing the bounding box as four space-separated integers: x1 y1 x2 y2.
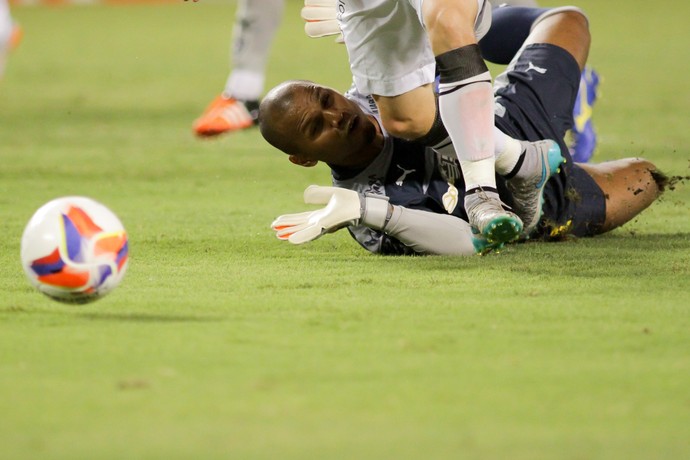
194 0 285 136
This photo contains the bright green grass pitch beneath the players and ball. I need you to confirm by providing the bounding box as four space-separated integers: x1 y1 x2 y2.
0 0 690 460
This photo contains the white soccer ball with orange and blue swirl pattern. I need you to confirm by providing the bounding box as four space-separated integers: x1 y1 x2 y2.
21 196 128 303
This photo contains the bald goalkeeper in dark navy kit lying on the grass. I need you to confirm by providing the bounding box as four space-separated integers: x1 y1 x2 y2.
259 8 667 255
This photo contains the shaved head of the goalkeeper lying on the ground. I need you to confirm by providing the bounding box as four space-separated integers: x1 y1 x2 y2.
259 80 384 168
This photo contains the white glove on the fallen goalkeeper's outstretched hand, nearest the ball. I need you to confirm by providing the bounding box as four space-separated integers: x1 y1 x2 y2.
271 185 391 244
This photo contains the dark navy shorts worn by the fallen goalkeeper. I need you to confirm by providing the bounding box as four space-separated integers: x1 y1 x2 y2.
496 44 606 239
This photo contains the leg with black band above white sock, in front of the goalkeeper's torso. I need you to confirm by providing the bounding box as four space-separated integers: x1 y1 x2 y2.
421 0 522 242
